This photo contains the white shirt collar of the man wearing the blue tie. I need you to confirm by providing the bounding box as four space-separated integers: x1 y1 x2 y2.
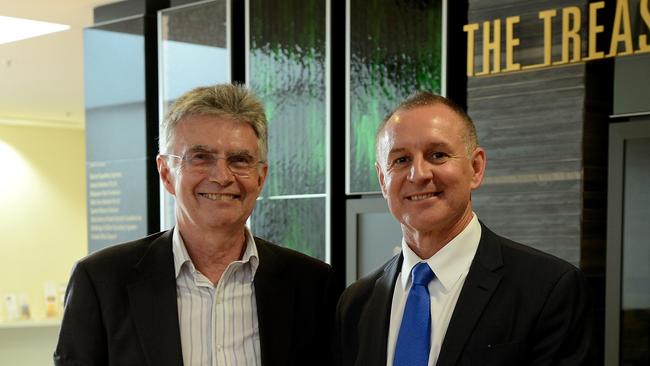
400 214 481 291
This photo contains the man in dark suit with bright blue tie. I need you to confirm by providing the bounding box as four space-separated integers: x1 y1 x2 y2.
336 92 590 366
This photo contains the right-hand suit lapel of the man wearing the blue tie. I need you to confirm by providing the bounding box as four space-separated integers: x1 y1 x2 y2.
436 223 503 366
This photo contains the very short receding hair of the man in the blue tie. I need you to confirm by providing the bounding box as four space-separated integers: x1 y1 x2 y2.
375 91 478 161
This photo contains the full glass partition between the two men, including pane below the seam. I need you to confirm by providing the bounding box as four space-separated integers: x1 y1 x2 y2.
247 0 328 260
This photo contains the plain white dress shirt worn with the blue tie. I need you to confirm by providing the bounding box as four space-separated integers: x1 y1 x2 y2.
386 214 481 366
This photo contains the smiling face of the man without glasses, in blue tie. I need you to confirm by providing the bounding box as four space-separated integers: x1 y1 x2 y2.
376 104 485 237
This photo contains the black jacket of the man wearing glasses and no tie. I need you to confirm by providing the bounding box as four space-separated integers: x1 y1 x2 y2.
54 231 336 366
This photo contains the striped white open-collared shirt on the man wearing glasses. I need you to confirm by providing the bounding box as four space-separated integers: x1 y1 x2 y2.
172 228 262 366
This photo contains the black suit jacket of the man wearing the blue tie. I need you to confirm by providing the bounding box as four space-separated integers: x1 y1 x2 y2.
335 225 590 366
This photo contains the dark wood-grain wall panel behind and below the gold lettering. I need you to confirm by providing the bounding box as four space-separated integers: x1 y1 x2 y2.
467 0 613 365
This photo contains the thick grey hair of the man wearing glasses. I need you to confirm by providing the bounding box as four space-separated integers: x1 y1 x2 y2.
158 84 268 161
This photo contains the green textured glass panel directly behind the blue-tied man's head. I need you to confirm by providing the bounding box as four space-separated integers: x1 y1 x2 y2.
348 0 443 193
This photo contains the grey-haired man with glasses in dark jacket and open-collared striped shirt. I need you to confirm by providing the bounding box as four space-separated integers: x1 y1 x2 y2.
54 85 336 366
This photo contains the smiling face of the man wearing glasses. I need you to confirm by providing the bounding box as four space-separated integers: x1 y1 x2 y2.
158 115 267 230
